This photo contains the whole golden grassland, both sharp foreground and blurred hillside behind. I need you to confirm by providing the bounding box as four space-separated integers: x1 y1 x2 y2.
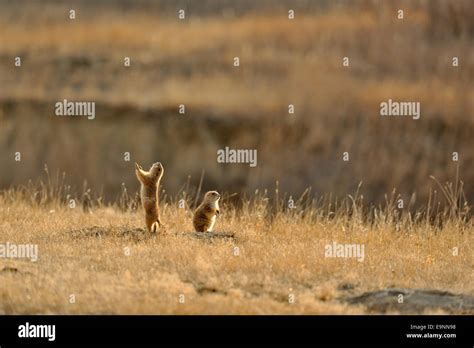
0 0 474 314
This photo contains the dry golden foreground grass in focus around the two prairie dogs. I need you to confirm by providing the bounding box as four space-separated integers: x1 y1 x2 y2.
0 174 474 314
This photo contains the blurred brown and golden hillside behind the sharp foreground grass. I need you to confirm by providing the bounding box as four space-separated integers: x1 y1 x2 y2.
0 0 474 202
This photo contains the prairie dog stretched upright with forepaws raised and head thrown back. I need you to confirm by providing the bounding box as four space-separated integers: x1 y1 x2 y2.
135 162 164 233
